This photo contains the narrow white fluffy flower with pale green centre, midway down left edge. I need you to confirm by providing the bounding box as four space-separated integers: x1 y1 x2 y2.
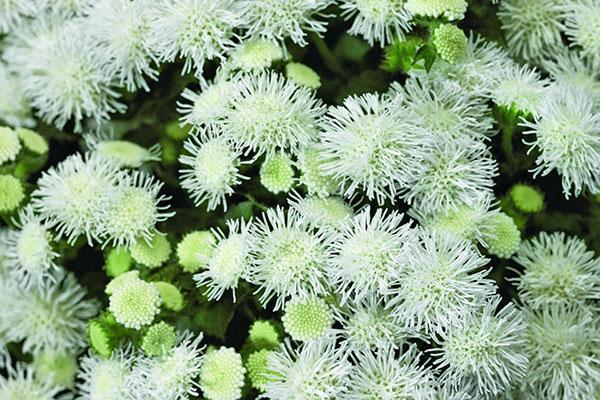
0 207 58 288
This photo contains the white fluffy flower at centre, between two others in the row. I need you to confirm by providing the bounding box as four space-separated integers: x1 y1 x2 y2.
328 207 412 303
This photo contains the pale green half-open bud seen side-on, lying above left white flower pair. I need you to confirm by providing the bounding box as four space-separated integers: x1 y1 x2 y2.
96 140 160 168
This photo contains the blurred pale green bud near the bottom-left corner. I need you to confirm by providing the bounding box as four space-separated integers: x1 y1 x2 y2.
33 349 78 389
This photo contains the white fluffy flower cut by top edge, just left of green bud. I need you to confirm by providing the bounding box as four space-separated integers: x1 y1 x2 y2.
340 0 411 46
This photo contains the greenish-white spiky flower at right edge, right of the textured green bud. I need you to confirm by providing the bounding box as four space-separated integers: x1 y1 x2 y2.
514 232 600 309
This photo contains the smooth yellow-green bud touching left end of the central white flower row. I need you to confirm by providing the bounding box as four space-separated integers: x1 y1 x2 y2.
177 231 217 274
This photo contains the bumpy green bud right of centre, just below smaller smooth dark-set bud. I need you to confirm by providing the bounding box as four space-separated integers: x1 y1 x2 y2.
483 212 521 258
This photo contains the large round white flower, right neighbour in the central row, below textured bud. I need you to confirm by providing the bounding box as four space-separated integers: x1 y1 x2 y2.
386 231 495 333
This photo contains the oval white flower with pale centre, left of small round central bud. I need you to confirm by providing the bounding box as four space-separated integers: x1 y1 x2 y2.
179 131 247 210
